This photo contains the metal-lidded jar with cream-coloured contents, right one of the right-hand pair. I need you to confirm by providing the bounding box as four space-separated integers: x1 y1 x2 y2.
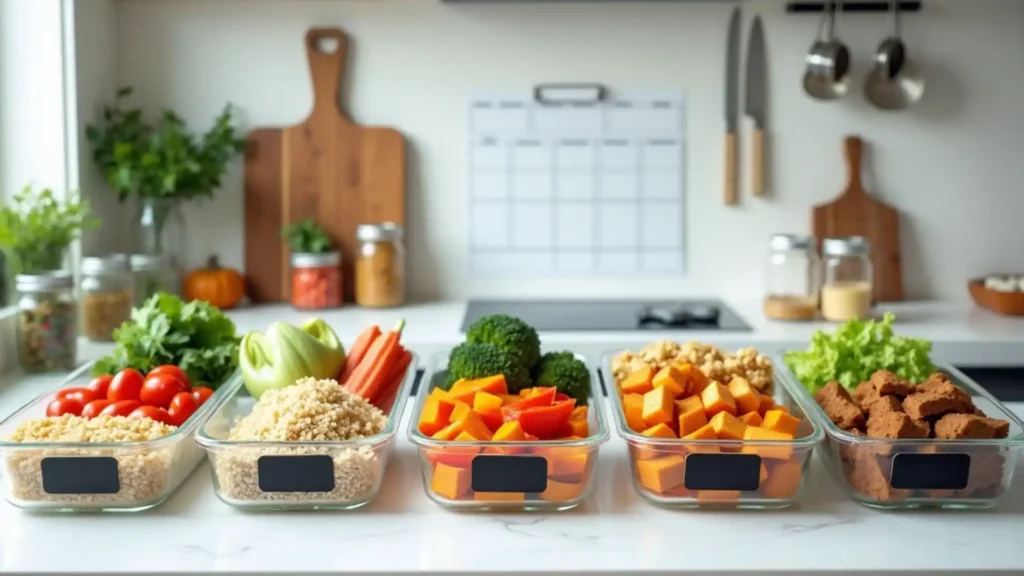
821 236 873 322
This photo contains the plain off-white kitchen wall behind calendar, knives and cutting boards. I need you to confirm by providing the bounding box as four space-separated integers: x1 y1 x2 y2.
77 0 1024 300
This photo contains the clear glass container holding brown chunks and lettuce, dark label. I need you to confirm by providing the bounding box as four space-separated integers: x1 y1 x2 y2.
775 355 1024 509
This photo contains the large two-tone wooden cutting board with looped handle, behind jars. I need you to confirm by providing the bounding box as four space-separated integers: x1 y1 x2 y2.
245 28 406 302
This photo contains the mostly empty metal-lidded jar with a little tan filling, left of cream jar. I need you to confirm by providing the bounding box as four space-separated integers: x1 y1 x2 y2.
764 234 821 320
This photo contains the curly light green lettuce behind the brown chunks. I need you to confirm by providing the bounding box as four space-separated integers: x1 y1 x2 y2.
784 313 935 394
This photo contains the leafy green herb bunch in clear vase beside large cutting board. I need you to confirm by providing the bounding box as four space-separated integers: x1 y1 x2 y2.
85 88 244 269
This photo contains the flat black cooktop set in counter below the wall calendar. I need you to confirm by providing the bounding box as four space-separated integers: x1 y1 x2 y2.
462 299 751 332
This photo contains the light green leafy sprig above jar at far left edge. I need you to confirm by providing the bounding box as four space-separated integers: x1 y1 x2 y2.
0 184 99 274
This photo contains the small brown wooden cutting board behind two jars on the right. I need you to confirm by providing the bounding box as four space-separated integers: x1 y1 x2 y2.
811 136 903 302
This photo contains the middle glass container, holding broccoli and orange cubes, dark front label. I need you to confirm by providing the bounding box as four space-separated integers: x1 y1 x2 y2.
409 352 608 510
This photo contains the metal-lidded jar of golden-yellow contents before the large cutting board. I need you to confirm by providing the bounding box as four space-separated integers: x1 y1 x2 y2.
355 222 406 307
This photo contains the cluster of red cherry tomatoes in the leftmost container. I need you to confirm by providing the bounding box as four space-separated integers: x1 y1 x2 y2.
46 365 213 426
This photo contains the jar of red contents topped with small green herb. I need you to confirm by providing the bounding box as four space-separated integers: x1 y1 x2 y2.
281 220 341 310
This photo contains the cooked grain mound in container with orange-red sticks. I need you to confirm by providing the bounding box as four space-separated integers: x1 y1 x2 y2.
211 378 387 506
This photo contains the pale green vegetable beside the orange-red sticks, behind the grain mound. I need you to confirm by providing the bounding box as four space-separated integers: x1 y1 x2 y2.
239 319 345 399
